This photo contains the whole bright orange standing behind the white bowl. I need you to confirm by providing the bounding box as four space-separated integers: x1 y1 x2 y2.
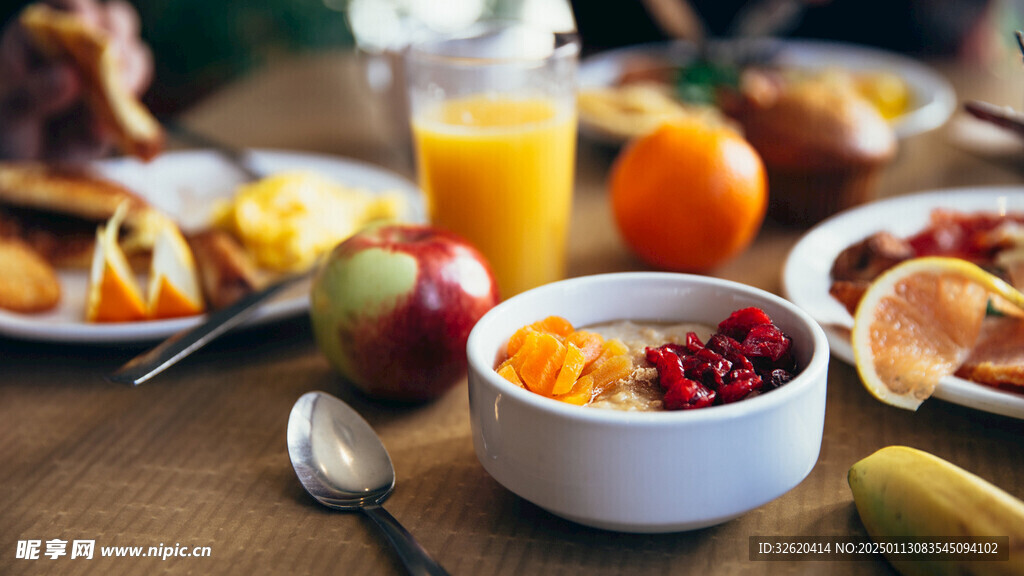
609 119 768 272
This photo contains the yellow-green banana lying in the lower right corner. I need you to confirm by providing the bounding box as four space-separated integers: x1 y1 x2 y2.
847 446 1024 576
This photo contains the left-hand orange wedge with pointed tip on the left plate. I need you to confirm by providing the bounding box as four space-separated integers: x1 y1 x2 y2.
85 204 146 322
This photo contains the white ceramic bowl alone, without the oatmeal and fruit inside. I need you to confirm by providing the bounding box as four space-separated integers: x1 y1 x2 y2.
467 273 828 532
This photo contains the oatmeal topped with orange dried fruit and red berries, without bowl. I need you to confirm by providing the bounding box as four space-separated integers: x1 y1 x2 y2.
496 307 799 411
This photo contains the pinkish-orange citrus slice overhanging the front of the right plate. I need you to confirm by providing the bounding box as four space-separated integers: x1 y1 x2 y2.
851 256 1024 410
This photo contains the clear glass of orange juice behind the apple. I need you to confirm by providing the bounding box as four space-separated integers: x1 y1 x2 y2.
407 25 580 297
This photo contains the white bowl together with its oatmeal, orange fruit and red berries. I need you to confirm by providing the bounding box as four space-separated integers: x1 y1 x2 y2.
467 273 828 533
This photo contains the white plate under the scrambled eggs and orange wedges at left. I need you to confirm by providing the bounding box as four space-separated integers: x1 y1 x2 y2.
0 151 425 343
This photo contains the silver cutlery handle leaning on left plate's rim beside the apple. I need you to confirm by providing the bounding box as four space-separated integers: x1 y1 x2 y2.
106 270 313 386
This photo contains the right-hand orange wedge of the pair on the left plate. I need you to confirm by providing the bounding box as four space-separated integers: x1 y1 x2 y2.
148 220 205 319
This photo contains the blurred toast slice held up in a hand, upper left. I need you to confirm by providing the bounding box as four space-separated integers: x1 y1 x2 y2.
19 4 164 160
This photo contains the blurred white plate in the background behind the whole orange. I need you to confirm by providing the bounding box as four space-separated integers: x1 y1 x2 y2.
579 40 956 141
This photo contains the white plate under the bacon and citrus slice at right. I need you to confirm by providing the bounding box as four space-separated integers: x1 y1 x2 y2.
782 187 1024 418
